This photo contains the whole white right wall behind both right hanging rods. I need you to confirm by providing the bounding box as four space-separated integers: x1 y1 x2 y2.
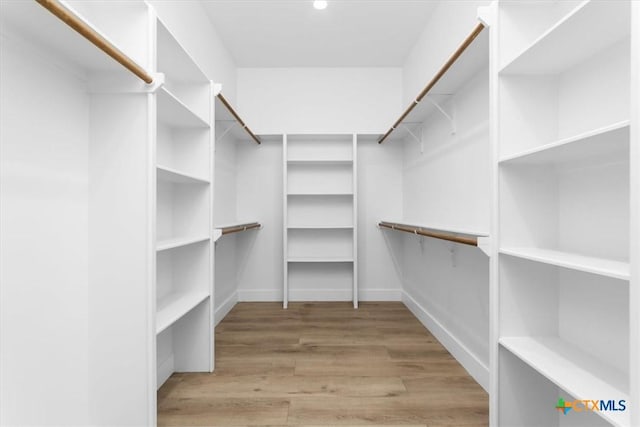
398 1 491 389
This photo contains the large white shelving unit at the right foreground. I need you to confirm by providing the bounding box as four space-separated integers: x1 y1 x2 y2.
491 1 639 426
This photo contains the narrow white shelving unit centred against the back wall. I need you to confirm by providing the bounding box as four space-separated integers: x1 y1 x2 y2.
283 135 358 308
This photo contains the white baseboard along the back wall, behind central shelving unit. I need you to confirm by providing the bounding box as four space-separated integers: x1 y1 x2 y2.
238 289 402 302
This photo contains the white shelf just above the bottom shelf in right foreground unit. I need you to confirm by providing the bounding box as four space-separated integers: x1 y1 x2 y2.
500 247 630 280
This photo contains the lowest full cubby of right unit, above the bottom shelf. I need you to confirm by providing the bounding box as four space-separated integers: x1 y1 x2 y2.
499 255 629 380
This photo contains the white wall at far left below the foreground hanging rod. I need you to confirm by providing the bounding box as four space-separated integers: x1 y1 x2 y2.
0 35 89 425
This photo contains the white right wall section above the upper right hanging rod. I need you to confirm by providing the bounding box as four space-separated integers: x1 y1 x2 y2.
402 0 491 107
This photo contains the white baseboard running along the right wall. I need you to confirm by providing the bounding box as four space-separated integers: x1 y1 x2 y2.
402 291 489 392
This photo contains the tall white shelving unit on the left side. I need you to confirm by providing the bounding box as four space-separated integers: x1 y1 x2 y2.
155 15 214 398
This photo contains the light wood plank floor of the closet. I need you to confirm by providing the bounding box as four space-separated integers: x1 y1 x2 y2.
158 302 489 427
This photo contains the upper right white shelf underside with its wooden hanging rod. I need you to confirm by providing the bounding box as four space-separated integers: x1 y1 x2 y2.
378 23 489 144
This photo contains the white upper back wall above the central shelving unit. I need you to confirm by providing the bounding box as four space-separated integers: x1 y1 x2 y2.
238 68 402 134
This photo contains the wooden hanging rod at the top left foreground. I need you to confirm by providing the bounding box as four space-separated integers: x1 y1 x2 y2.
36 0 153 84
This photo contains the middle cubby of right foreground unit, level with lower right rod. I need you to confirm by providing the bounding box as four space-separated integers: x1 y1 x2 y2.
499 150 630 263
